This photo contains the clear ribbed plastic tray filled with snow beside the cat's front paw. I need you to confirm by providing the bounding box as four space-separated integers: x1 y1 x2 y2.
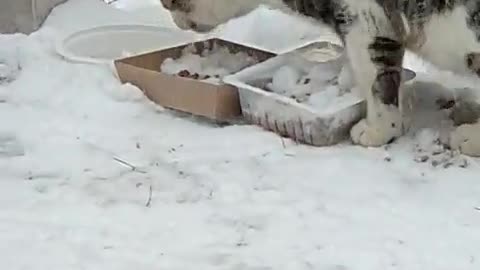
224 51 415 146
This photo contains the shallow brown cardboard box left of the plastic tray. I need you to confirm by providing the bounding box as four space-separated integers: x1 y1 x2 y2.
115 38 275 121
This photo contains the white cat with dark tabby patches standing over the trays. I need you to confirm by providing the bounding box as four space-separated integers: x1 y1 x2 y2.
161 0 480 156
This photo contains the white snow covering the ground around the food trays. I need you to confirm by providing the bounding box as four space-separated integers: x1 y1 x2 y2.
0 0 480 270
